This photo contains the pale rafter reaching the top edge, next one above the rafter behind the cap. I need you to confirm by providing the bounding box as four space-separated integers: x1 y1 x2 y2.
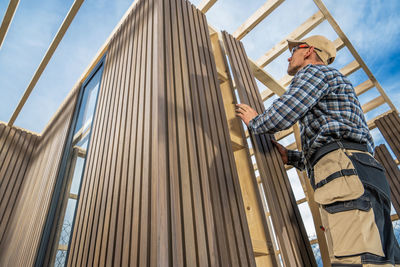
233 0 285 40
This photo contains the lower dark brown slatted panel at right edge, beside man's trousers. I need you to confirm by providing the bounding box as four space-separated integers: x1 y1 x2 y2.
375 144 400 216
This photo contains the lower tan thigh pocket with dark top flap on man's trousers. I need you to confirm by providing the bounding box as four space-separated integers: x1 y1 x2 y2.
321 199 385 257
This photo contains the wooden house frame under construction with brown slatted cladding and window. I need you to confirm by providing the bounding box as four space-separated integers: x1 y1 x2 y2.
0 0 400 266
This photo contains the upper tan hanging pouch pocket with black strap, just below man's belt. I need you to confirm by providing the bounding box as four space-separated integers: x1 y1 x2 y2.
313 149 364 205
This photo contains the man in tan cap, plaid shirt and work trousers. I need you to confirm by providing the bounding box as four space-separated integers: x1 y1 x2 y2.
236 36 400 266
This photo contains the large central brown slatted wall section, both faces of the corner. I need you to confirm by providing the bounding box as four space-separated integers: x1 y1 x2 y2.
68 0 255 266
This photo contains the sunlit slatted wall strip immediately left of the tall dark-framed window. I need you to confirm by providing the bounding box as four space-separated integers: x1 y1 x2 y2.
0 90 77 266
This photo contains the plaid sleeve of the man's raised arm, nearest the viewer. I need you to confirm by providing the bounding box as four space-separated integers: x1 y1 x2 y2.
248 65 329 134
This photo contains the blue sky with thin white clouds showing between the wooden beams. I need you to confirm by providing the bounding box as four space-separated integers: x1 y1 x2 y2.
0 0 400 252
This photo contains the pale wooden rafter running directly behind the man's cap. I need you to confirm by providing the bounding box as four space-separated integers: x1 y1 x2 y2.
257 11 325 68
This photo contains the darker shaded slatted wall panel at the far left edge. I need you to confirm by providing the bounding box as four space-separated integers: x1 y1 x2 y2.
0 124 38 243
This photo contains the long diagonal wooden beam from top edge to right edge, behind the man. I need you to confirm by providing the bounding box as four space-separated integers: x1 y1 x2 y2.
314 0 398 113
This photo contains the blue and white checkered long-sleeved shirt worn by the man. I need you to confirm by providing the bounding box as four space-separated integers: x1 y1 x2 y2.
249 64 374 170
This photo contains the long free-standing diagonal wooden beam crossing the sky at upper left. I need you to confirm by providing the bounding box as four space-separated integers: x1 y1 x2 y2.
8 0 83 126
